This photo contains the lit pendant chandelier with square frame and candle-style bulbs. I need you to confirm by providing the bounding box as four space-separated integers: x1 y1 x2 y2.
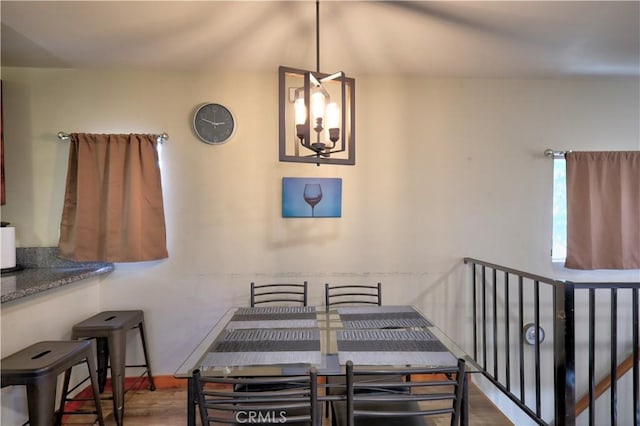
278 1 355 166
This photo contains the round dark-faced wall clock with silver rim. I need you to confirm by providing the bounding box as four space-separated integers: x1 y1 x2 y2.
193 103 236 144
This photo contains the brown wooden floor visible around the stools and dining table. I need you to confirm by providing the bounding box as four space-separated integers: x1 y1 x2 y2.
64 378 513 426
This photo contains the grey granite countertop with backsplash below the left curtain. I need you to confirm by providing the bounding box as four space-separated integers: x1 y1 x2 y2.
0 247 114 303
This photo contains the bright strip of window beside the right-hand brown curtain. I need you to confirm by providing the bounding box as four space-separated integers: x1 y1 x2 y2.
551 157 567 262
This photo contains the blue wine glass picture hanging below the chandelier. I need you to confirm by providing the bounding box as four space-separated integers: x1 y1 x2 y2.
282 178 342 217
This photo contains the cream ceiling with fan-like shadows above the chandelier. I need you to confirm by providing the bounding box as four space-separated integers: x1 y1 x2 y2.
0 0 640 77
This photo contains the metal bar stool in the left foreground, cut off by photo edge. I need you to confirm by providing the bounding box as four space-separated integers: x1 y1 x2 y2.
1 340 104 426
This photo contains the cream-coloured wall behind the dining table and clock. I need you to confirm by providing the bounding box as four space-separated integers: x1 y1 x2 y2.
2 68 640 422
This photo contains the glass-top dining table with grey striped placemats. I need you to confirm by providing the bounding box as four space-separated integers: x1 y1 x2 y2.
174 305 480 426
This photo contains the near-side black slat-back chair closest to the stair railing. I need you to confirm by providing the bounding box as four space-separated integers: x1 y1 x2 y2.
331 359 465 426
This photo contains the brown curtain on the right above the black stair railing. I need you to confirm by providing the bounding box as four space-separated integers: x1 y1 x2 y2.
565 151 640 269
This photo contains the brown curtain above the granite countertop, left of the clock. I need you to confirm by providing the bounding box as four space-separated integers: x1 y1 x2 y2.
59 133 168 262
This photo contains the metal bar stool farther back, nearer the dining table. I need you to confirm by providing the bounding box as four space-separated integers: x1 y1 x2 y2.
71 311 156 425
